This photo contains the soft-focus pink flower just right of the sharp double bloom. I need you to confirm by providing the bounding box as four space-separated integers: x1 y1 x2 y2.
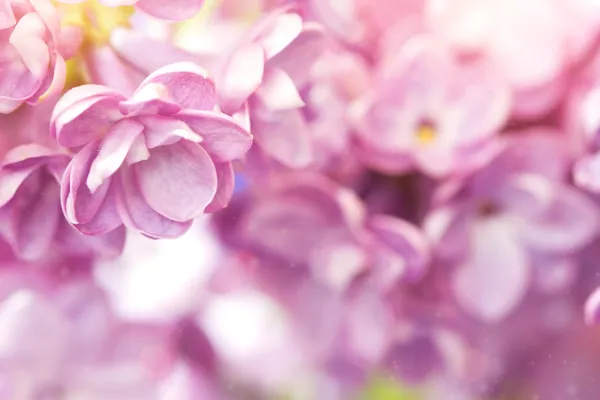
219 8 324 168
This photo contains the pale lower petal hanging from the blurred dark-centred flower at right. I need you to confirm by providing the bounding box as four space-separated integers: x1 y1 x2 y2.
452 215 530 322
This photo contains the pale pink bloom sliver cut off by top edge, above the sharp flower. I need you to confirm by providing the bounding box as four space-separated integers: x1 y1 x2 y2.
58 0 204 21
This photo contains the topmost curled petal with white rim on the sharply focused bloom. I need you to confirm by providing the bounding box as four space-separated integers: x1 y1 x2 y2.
133 62 217 110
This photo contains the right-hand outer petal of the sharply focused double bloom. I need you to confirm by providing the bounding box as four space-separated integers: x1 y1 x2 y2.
177 110 252 162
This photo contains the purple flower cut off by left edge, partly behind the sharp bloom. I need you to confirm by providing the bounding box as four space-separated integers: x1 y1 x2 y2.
0 144 125 260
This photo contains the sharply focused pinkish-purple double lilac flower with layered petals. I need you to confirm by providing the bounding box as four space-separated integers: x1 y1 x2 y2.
51 63 252 238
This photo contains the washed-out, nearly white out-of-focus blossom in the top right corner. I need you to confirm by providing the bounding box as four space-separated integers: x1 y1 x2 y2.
426 0 599 118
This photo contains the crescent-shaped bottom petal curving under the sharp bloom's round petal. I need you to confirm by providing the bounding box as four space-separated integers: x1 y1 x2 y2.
117 168 193 238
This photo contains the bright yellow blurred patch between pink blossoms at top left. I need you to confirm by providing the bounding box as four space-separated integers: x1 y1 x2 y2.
56 0 135 46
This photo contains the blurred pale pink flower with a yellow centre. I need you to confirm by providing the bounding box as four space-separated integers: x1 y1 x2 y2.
354 37 510 177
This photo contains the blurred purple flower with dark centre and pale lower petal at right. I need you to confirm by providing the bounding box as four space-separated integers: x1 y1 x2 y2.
425 130 600 321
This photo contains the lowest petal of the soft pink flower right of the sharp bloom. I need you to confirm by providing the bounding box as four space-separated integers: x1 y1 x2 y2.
252 109 314 168
